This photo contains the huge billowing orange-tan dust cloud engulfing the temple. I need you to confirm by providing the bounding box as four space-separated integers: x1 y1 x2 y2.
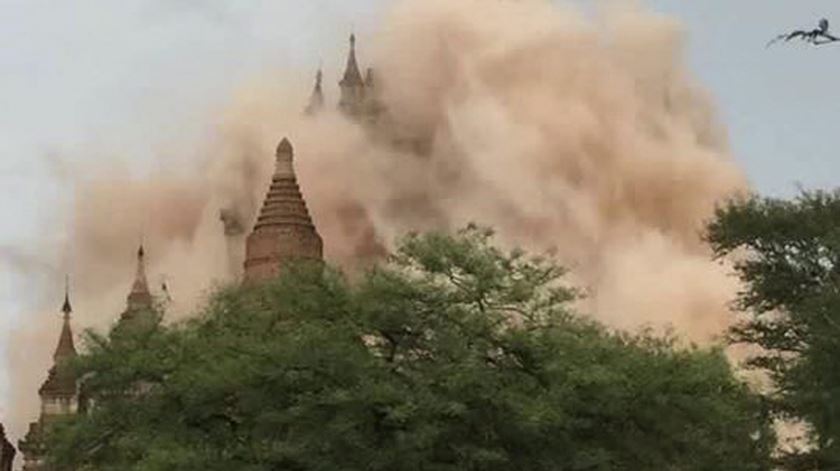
0 0 746 452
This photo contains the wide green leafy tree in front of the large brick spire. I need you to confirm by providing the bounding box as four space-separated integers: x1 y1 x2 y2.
50 227 772 471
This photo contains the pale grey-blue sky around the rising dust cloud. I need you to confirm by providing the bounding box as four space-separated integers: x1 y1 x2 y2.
0 0 840 420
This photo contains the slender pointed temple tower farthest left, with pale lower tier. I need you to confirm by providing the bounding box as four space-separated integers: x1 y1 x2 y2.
18 289 79 471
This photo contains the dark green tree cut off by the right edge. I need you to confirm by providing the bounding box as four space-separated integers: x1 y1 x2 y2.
708 192 840 469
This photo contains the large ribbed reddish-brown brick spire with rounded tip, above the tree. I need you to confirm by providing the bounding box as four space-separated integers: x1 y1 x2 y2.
245 139 323 282
